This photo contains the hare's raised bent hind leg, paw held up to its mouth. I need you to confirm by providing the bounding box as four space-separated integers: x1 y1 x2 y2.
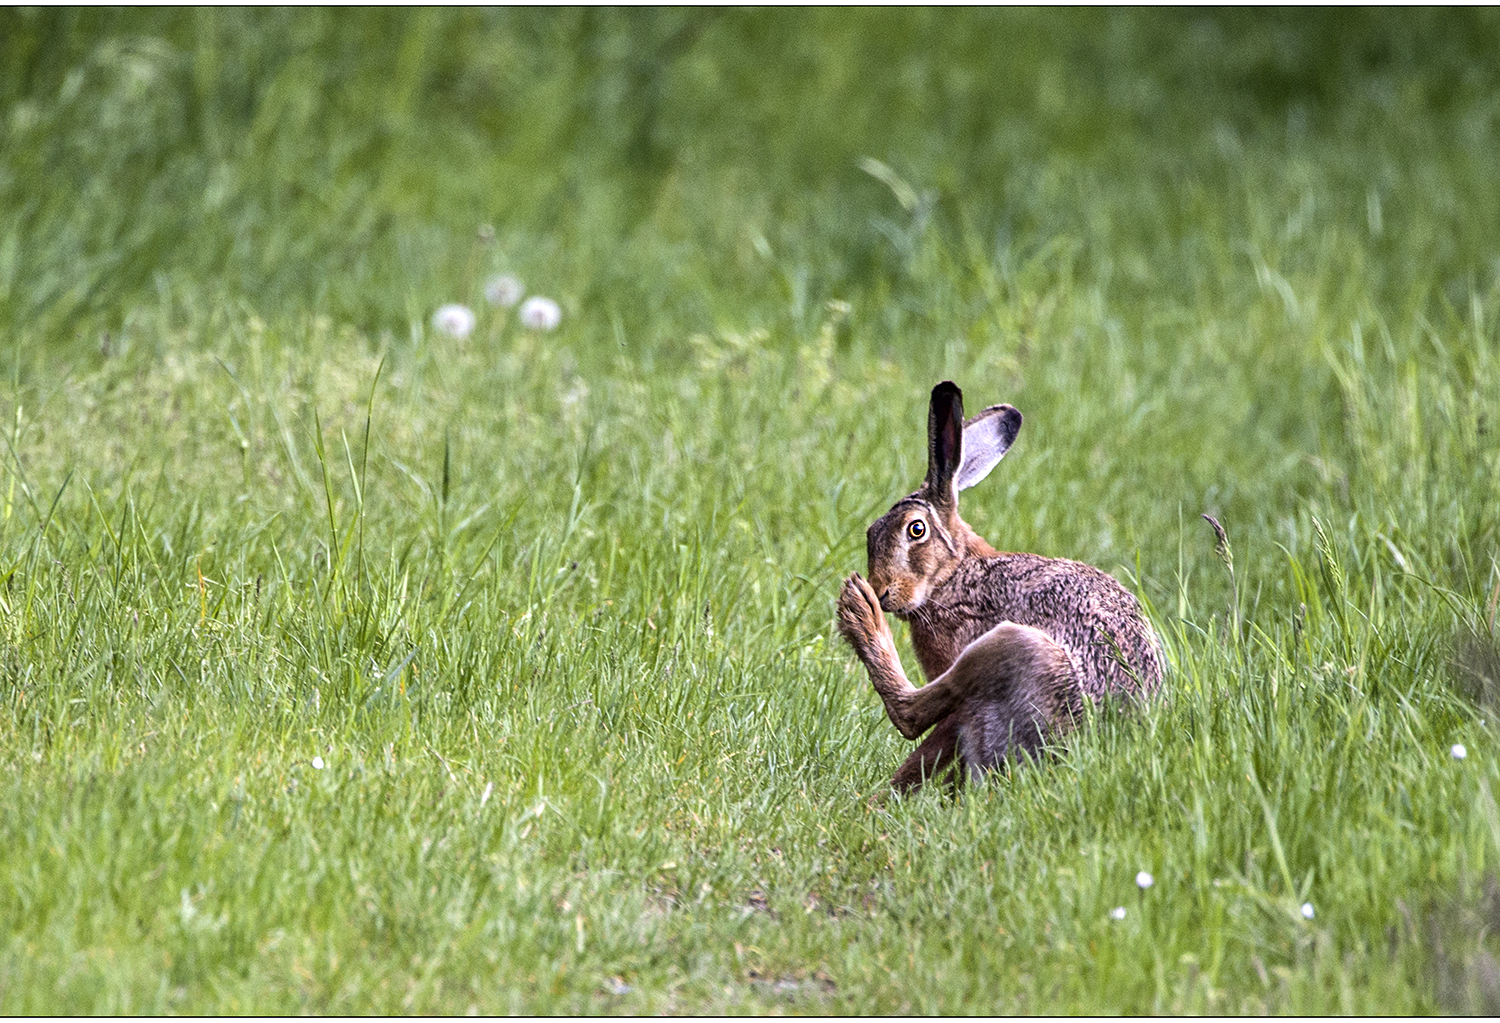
839 575 1076 740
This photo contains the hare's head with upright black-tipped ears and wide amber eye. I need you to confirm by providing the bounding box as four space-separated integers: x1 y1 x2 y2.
866 381 1022 614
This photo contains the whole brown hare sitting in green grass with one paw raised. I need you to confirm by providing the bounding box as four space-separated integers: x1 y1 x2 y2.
839 381 1163 792
